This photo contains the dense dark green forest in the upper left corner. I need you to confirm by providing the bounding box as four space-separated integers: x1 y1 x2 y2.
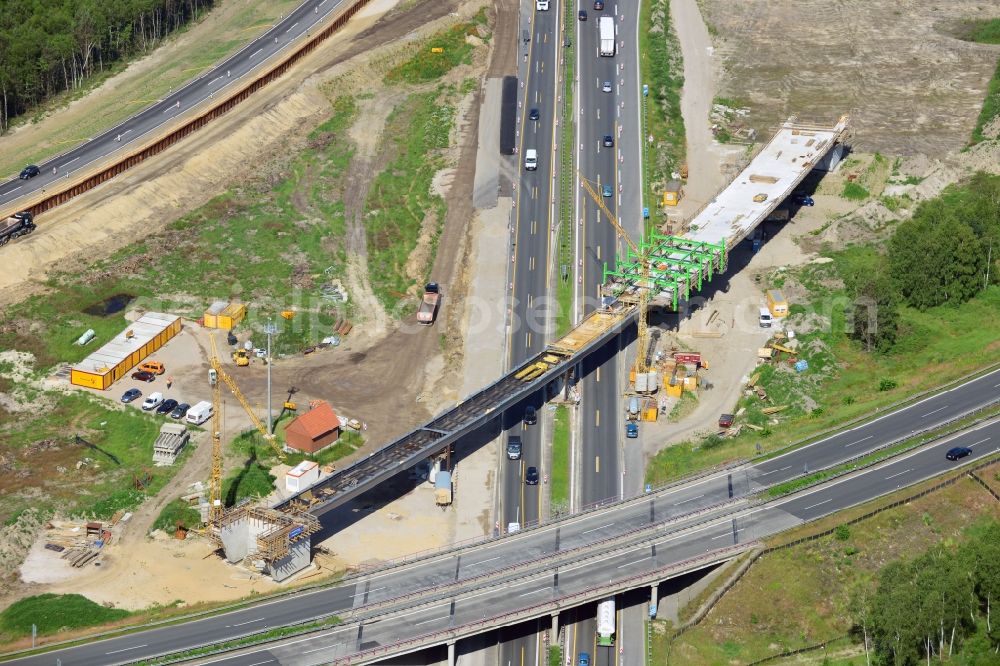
0 0 214 133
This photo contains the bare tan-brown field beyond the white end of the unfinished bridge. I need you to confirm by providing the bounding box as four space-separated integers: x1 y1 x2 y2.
689 0 1000 155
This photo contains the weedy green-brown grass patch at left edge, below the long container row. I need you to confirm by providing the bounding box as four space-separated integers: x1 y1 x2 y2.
0 393 184 522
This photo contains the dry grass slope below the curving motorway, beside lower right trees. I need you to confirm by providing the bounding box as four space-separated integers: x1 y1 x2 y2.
653 465 1000 666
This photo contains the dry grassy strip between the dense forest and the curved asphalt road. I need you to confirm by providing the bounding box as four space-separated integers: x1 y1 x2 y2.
0 0 299 179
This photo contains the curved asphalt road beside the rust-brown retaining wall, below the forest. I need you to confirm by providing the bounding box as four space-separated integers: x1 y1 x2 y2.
0 0 352 206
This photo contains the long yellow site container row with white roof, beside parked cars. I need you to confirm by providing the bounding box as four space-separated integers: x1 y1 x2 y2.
69 312 181 390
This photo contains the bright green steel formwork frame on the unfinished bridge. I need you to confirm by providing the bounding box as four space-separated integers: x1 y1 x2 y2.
604 231 726 310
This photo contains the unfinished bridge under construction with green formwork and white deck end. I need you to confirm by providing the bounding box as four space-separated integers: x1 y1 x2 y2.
219 116 847 581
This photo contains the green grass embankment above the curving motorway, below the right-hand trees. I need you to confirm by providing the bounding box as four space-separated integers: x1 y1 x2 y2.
646 278 1000 484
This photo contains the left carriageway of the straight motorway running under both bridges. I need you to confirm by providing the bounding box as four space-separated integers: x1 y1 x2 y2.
497 0 562 663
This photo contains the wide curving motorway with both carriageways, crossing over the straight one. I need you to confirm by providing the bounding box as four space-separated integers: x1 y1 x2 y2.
10 371 1000 666
